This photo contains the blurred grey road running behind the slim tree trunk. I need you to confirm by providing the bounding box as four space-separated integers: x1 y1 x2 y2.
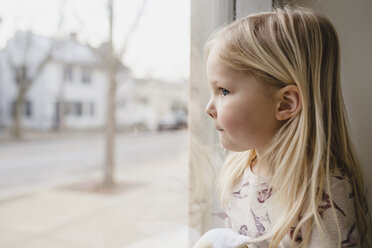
0 130 188 193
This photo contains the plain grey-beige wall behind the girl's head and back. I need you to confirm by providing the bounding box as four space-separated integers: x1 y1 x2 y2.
302 0 372 231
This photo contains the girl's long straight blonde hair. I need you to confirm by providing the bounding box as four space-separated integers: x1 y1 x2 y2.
205 7 371 247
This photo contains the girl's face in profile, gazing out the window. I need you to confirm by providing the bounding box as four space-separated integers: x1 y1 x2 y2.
205 44 281 152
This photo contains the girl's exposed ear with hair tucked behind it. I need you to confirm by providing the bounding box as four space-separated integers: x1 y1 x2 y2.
275 85 302 121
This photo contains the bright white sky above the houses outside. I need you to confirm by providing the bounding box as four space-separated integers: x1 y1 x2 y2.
0 0 190 82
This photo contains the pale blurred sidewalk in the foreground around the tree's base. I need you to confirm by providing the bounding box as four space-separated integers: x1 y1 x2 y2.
0 154 197 248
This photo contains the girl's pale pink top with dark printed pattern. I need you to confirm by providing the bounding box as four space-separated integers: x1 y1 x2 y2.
225 166 359 248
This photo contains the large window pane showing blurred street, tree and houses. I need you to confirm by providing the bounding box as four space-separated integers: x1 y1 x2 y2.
0 0 190 248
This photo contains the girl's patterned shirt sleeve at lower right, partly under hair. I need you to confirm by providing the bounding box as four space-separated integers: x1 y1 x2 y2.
309 176 360 248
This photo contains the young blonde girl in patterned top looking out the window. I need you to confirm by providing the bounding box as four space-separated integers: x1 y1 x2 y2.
199 7 372 247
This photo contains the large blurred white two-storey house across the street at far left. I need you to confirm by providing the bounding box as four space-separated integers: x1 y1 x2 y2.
0 32 107 129
